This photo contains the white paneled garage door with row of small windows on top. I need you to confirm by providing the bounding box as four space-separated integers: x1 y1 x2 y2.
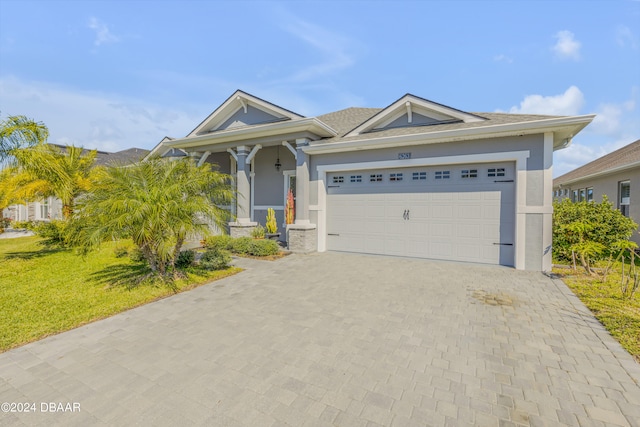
327 163 515 265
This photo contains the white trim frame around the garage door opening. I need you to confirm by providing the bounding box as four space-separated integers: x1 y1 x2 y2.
316 150 530 270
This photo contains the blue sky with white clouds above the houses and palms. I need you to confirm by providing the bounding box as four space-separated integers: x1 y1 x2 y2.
0 0 640 176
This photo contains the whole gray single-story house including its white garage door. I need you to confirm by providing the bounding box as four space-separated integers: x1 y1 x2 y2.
151 91 594 271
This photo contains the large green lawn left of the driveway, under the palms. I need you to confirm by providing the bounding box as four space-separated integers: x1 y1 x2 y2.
0 237 240 352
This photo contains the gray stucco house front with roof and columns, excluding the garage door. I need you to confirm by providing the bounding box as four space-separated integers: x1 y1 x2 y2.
155 91 593 271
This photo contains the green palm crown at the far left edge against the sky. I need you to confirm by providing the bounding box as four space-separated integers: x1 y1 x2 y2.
0 116 49 164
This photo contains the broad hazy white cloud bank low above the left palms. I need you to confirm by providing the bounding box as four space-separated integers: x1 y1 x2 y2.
0 77 202 151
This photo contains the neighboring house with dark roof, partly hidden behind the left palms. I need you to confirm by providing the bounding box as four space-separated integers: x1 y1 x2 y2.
2 144 149 221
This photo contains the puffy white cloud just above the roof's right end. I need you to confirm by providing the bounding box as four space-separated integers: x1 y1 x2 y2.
509 86 585 116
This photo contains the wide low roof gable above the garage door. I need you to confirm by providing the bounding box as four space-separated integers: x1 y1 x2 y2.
345 93 486 136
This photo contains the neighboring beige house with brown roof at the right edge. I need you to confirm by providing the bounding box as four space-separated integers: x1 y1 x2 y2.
553 139 640 244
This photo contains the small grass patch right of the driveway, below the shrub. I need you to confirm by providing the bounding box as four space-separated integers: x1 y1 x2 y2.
553 266 640 362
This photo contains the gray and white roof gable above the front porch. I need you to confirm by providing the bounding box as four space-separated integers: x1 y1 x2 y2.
187 90 304 137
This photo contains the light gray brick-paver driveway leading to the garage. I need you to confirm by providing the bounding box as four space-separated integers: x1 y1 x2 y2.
0 253 640 427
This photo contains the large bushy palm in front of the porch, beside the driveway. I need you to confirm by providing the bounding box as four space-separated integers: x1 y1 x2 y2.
73 158 234 276
